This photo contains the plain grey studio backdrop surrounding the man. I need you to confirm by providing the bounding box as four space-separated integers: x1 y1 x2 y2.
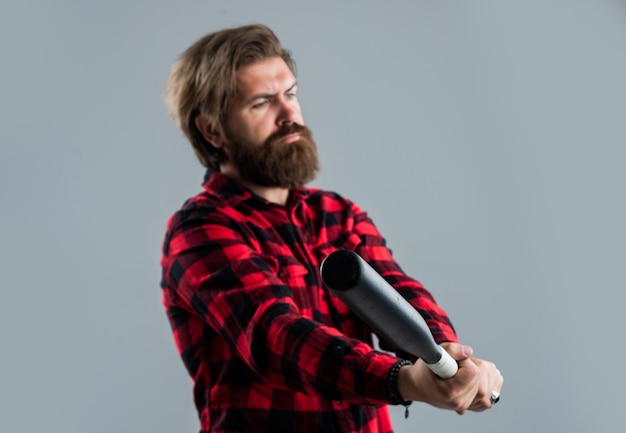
0 0 626 433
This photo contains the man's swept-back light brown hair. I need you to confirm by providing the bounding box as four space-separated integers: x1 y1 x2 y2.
165 24 296 169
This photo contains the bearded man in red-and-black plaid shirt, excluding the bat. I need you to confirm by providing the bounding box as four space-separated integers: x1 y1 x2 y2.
161 25 502 433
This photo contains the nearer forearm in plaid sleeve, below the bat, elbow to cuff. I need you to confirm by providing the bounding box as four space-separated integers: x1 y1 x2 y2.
245 296 397 404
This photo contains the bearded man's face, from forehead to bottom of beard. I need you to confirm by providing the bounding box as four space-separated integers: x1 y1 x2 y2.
219 57 318 188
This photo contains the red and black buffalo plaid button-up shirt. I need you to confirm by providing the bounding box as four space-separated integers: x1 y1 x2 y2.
161 172 457 433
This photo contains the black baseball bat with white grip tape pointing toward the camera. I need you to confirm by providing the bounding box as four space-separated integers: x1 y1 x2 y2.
320 250 458 379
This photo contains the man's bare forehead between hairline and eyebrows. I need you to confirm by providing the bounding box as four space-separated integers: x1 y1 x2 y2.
237 57 296 97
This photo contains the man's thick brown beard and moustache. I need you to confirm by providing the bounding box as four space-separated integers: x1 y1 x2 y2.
224 123 319 189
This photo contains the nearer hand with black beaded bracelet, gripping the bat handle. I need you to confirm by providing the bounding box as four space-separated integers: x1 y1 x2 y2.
398 343 480 414
